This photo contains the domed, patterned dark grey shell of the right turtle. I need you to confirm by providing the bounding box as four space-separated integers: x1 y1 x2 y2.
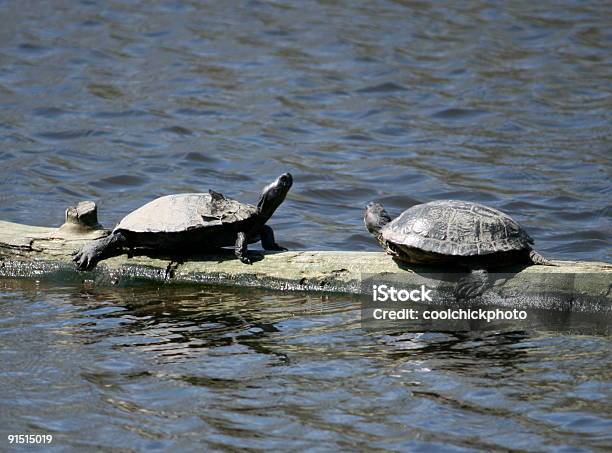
381 200 533 256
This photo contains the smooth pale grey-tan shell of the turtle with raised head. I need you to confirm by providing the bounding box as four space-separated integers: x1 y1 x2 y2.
115 191 257 233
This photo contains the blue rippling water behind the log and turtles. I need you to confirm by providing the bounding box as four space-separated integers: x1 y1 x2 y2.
0 1 612 260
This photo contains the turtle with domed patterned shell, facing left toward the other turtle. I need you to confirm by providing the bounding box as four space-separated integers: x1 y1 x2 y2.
364 200 554 297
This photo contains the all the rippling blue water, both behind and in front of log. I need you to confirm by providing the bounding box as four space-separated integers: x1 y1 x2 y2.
0 0 612 451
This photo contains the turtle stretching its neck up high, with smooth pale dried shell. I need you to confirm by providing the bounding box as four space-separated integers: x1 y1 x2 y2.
73 173 293 270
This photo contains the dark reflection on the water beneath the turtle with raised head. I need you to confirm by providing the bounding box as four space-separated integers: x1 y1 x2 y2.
74 288 290 360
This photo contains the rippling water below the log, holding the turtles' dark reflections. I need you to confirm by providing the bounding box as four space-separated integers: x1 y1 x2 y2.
0 283 612 451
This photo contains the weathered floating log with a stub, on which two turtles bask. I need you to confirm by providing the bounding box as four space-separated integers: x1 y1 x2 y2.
0 202 612 312
